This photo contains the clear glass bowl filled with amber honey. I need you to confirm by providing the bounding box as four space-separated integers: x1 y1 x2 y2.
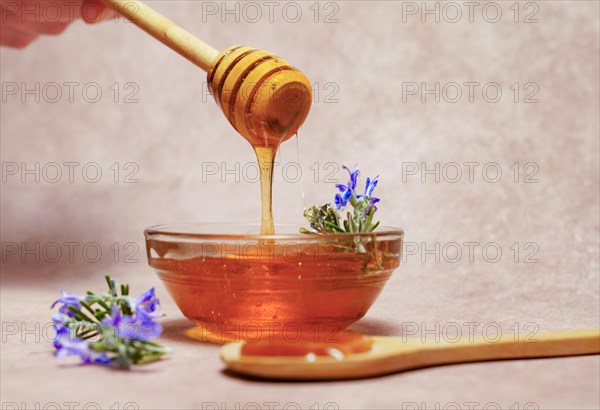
144 223 404 343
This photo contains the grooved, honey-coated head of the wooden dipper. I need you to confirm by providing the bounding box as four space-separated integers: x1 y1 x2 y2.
208 46 312 148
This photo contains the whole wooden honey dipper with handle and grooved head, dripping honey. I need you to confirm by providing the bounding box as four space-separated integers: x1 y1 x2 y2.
102 0 312 148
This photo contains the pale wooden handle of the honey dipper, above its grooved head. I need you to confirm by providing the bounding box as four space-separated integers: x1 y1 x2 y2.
102 0 219 71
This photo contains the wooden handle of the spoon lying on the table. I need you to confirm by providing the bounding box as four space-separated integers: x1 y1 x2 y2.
386 329 600 368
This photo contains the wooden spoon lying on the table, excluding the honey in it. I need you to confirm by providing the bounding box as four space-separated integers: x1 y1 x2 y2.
221 329 600 380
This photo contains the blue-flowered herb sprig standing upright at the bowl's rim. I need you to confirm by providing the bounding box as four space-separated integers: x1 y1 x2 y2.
300 165 380 234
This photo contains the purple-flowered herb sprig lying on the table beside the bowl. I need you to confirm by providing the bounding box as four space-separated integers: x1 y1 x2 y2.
51 276 168 368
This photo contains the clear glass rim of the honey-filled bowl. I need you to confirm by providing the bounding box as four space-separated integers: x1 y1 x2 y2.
144 222 404 241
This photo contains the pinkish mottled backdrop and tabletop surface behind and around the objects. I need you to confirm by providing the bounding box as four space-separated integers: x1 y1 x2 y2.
0 1 600 409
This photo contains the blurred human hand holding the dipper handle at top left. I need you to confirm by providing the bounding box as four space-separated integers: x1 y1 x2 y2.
0 0 115 48
